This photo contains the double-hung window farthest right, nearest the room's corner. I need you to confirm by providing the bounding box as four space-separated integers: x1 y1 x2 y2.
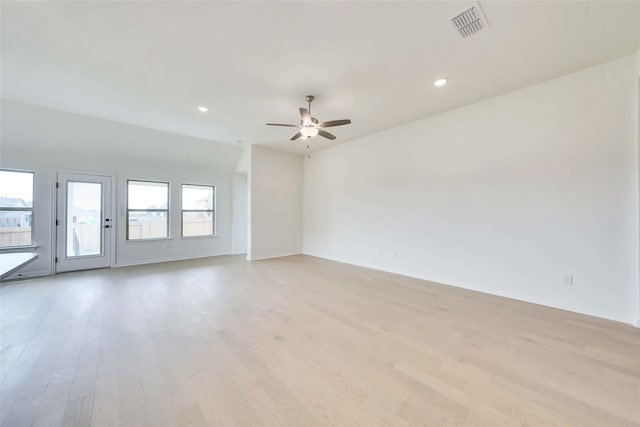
182 184 216 237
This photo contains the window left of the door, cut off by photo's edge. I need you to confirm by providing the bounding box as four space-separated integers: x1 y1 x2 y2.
0 170 33 248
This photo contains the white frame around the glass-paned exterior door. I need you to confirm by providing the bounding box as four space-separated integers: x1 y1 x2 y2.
51 169 118 275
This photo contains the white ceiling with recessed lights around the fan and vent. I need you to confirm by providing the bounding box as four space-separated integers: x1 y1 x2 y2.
1 1 640 152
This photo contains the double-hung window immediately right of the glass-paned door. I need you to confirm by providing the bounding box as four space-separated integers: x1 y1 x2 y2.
127 180 169 240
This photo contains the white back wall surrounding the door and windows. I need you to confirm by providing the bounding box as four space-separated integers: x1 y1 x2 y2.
0 100 242 276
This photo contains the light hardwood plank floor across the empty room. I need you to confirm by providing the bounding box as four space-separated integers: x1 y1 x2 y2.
0 256 640 427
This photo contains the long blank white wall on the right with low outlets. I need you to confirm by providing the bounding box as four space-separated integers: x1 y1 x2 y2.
303 57 639 323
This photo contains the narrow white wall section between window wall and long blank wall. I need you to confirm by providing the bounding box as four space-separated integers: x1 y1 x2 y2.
248 145 302 260
